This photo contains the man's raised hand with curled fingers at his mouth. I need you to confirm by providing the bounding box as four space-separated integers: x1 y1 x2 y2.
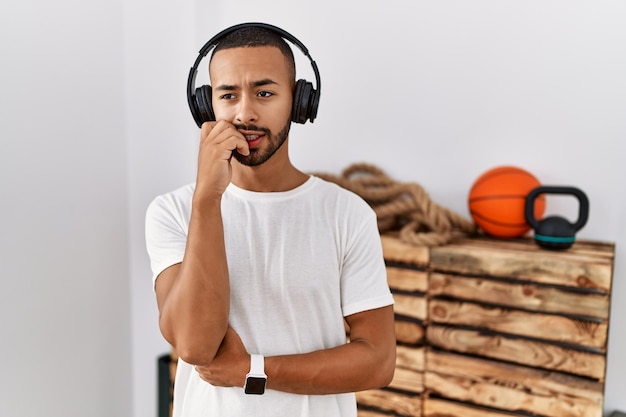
196 120 250 202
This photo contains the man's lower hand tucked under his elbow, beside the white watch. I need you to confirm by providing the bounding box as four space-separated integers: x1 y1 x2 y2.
195 326 250 387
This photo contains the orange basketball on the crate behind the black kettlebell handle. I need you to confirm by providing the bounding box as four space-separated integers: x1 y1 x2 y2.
468 166 545 238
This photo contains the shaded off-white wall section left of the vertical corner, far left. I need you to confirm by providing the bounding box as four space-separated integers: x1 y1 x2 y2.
0 0 132 417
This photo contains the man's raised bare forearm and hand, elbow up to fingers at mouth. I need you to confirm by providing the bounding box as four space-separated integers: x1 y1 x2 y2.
155 121 244 360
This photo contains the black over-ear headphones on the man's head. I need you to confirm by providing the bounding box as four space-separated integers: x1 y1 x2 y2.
187 23 320 127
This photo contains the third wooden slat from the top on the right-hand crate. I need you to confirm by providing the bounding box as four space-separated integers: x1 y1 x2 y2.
429 299 607 351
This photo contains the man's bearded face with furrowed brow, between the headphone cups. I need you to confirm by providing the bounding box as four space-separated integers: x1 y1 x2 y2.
209 46 294 166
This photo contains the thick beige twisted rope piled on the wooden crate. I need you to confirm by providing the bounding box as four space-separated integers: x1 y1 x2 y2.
314 164 477 246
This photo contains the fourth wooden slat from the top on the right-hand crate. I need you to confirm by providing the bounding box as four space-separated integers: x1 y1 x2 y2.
426 325 606 382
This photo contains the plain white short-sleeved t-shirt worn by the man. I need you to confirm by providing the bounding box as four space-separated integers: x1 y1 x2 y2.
146 177 393 417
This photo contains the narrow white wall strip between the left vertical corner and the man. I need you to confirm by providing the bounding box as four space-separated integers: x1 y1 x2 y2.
124 0 197 417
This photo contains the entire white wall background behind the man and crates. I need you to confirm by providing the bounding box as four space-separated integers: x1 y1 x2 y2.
0 0 626 417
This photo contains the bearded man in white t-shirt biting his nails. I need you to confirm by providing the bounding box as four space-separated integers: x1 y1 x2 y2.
146 23 395 417
